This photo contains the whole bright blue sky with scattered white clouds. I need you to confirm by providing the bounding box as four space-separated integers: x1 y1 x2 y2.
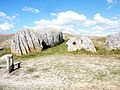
0 0 120 36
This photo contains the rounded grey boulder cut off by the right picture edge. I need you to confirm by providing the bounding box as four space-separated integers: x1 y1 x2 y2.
106 32 120 50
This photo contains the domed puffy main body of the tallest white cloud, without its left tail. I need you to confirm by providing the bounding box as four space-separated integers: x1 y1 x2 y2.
51 10 87 25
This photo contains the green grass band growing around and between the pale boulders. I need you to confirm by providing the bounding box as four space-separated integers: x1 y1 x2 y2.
0 37 120 60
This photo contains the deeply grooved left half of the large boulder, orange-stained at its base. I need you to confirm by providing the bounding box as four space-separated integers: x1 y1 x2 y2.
11 29 43 56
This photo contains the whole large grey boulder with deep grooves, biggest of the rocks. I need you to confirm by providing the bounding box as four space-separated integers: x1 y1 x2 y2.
11 29 63 56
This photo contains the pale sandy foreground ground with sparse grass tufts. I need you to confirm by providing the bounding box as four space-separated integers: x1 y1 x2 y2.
0 55 120 90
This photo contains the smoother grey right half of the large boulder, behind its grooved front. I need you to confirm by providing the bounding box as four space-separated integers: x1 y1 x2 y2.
34 29 63 46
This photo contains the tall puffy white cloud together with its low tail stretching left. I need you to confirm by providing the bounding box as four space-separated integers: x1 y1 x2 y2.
34 11 87 25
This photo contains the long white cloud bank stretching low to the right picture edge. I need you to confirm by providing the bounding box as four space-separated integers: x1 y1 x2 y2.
24 10 120 35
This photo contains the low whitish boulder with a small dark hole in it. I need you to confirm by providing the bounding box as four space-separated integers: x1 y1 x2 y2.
66 36 96 52
